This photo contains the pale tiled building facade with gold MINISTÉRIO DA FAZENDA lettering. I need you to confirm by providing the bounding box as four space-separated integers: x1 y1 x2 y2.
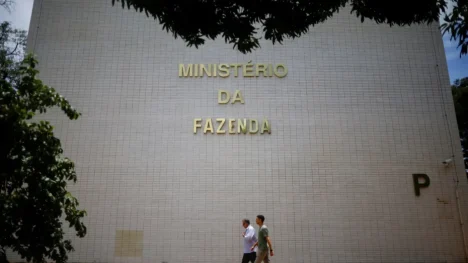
21 0 468 263
